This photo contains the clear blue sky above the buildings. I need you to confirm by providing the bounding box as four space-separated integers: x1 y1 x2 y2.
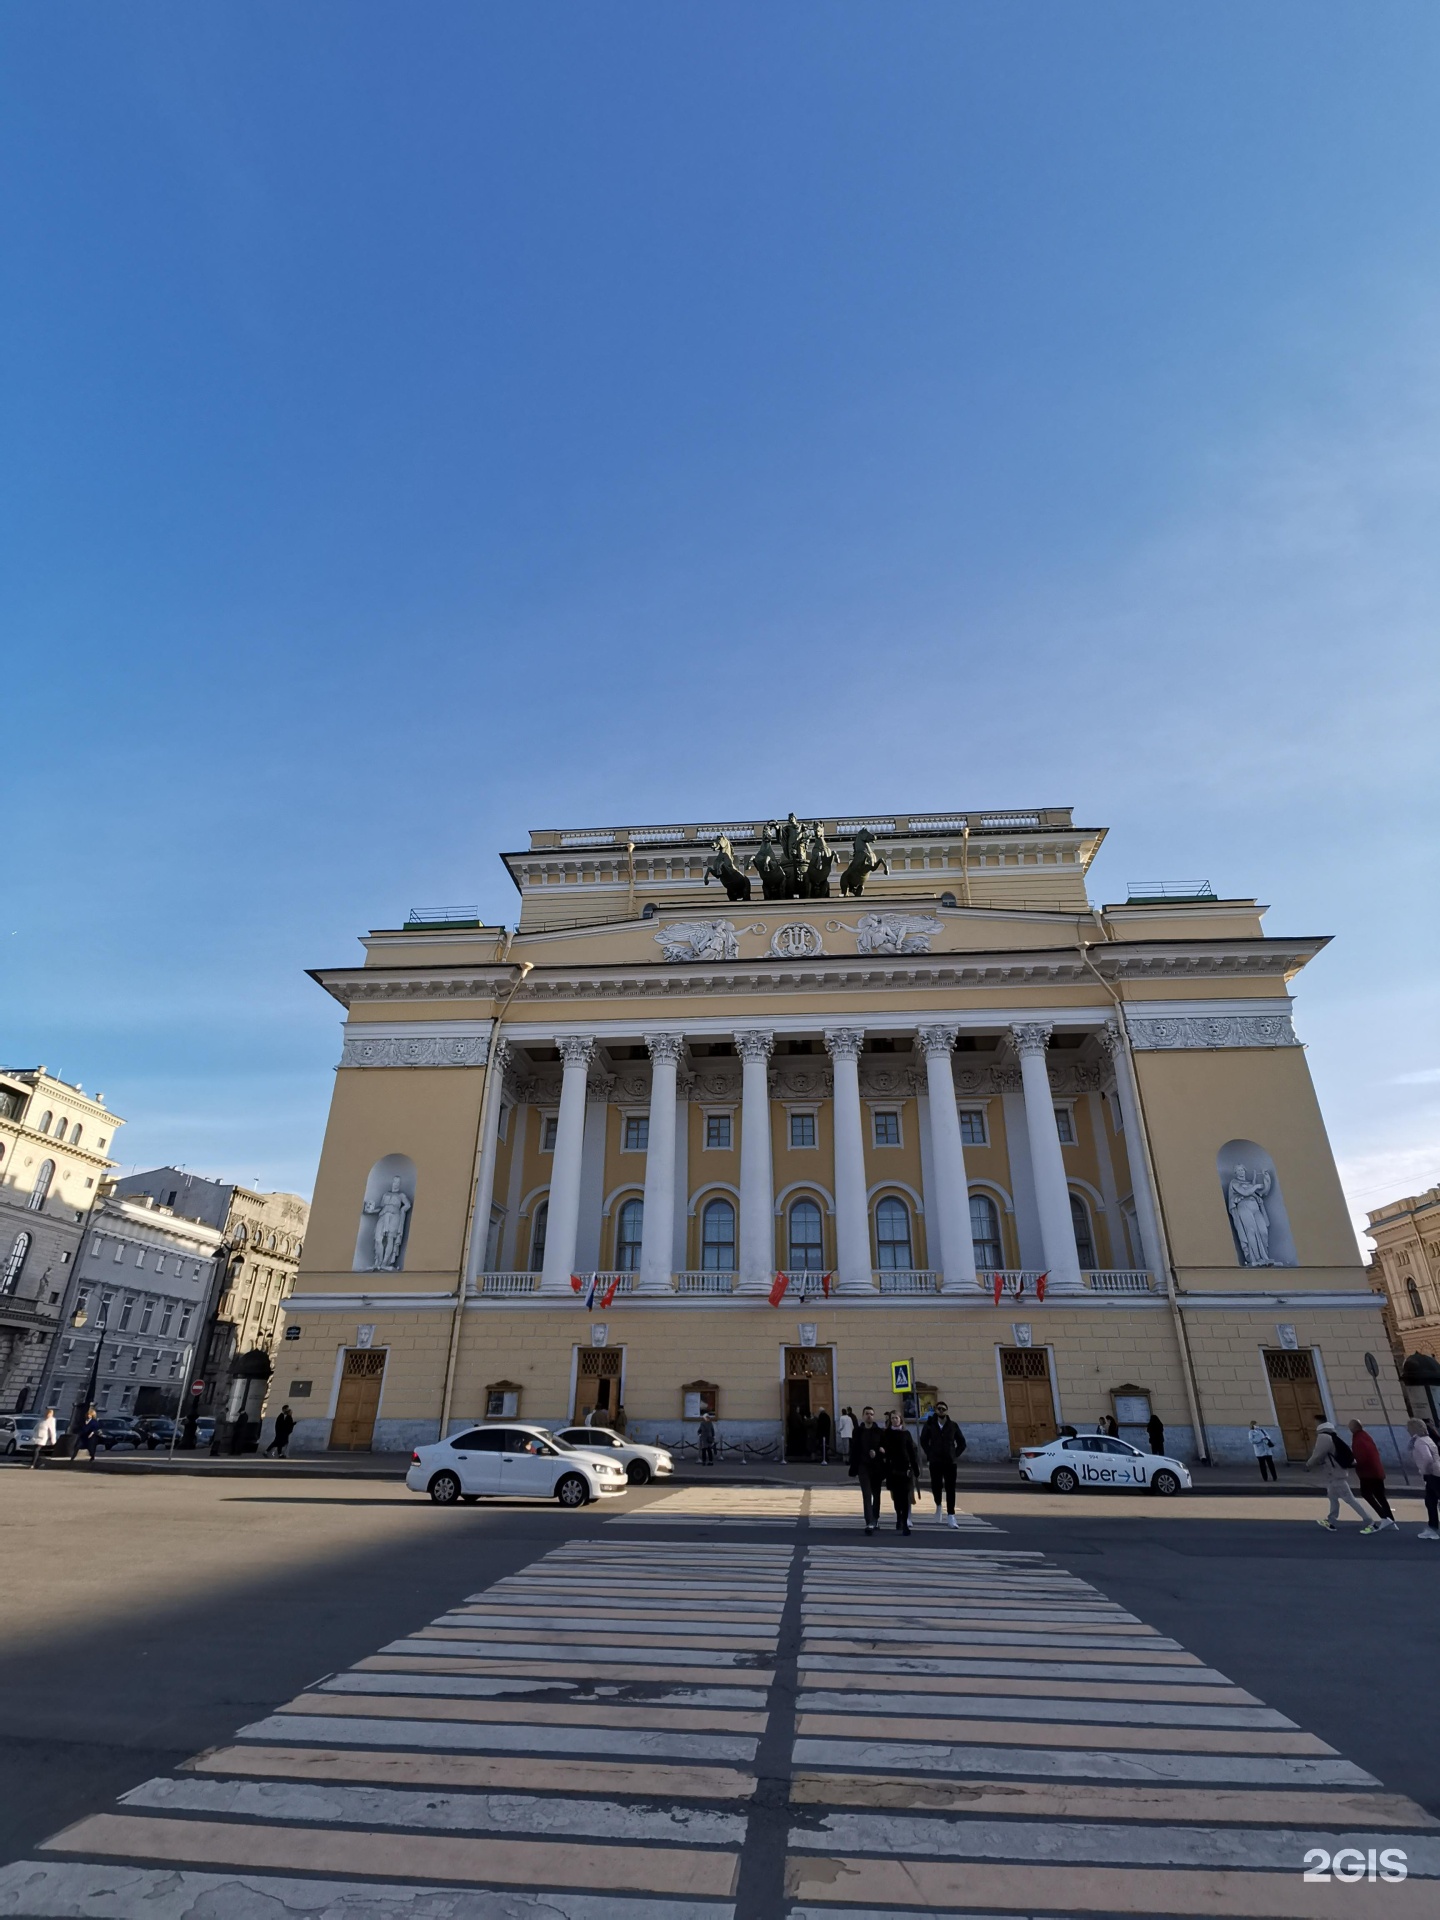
0 0 1440 1244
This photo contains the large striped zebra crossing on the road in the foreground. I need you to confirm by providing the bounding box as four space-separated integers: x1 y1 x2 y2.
0 1520 1440 1920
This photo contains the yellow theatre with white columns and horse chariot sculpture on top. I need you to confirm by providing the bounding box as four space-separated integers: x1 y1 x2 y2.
271 808 1384 1459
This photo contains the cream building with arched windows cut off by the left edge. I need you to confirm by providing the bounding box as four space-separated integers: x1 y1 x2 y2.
0 1068 125 1413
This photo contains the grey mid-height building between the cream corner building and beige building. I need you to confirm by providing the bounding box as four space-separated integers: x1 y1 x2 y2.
44 1190 225 1427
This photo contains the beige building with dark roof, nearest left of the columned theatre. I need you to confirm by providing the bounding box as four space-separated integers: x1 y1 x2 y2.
115 1167 309 1421
